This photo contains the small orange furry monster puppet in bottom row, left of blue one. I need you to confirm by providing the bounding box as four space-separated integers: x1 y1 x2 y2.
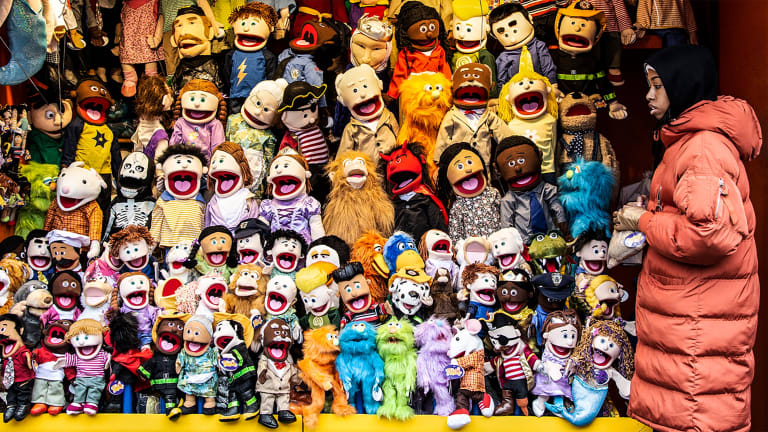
291 325 355 428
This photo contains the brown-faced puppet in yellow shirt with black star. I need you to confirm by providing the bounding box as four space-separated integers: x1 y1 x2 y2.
59 78 123 216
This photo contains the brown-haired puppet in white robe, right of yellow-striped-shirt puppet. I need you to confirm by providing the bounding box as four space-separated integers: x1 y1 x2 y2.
205 141 259 231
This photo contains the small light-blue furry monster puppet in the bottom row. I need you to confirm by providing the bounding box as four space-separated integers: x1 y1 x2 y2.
336 321 384 414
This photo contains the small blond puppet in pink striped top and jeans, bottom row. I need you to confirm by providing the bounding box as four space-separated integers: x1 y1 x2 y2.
53 319 112 415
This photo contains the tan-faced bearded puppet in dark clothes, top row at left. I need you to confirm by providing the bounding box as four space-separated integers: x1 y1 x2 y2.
170 6 227 93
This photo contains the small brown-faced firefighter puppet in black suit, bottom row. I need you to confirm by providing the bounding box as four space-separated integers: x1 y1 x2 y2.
138 312 189 415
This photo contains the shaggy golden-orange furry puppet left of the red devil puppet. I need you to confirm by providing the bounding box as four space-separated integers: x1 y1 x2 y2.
323 150 395 246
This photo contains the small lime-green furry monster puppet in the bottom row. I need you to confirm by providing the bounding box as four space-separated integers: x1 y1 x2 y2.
376 318 416 421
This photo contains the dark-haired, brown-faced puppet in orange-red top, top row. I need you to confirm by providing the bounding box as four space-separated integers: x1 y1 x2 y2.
387 1 451 99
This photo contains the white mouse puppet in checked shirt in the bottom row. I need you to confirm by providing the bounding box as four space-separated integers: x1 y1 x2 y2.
446 319 496 430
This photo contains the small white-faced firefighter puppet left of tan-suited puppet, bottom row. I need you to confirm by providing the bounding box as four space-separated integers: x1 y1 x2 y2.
213 313 260 422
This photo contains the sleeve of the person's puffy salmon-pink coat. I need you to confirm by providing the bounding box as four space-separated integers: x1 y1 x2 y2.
640 132 749 265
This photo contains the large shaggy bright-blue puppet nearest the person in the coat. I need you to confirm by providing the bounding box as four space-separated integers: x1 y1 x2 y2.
557 158 614 238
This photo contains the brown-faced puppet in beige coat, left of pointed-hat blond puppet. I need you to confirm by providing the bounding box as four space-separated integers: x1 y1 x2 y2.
432 63 512 166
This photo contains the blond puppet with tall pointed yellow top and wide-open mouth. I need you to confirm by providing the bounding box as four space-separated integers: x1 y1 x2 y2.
498 46 558 184
